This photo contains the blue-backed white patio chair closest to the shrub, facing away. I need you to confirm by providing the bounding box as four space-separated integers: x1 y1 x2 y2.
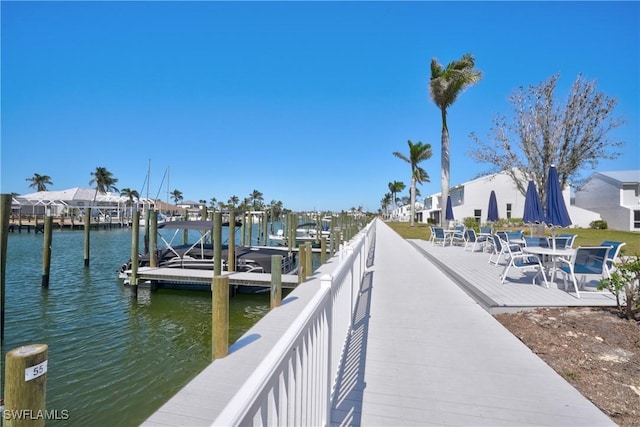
558 246 611 298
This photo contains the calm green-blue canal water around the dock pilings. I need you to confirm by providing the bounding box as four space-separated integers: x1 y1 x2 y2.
2 229 278 426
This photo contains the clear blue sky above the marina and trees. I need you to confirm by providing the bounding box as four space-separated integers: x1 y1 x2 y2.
0 1 640 211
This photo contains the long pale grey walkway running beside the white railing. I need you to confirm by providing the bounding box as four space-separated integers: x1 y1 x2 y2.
332 221 615 427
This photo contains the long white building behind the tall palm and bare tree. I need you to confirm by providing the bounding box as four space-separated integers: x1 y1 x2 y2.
422 172 600 227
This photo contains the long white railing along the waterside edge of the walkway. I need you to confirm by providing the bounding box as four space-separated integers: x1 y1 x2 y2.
213 220 375 426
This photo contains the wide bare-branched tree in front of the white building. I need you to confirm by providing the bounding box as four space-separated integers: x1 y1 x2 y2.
470 74 624 204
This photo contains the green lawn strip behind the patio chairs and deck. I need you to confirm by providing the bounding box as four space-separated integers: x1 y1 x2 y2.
386 222 640 255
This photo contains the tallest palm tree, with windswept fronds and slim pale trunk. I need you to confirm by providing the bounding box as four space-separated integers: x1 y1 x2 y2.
429 53 482 226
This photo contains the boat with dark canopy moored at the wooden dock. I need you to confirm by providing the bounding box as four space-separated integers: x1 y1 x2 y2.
118 221 295 279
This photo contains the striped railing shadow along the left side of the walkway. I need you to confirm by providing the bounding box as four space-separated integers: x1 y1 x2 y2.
331 270 373 427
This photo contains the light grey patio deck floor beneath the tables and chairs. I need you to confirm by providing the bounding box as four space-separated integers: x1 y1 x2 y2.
409 240 616 314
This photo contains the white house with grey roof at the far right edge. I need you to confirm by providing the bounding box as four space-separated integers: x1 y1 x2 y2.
575 170 640 231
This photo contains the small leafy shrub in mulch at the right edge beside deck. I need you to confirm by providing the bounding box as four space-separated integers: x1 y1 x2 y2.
598 255 640 319
